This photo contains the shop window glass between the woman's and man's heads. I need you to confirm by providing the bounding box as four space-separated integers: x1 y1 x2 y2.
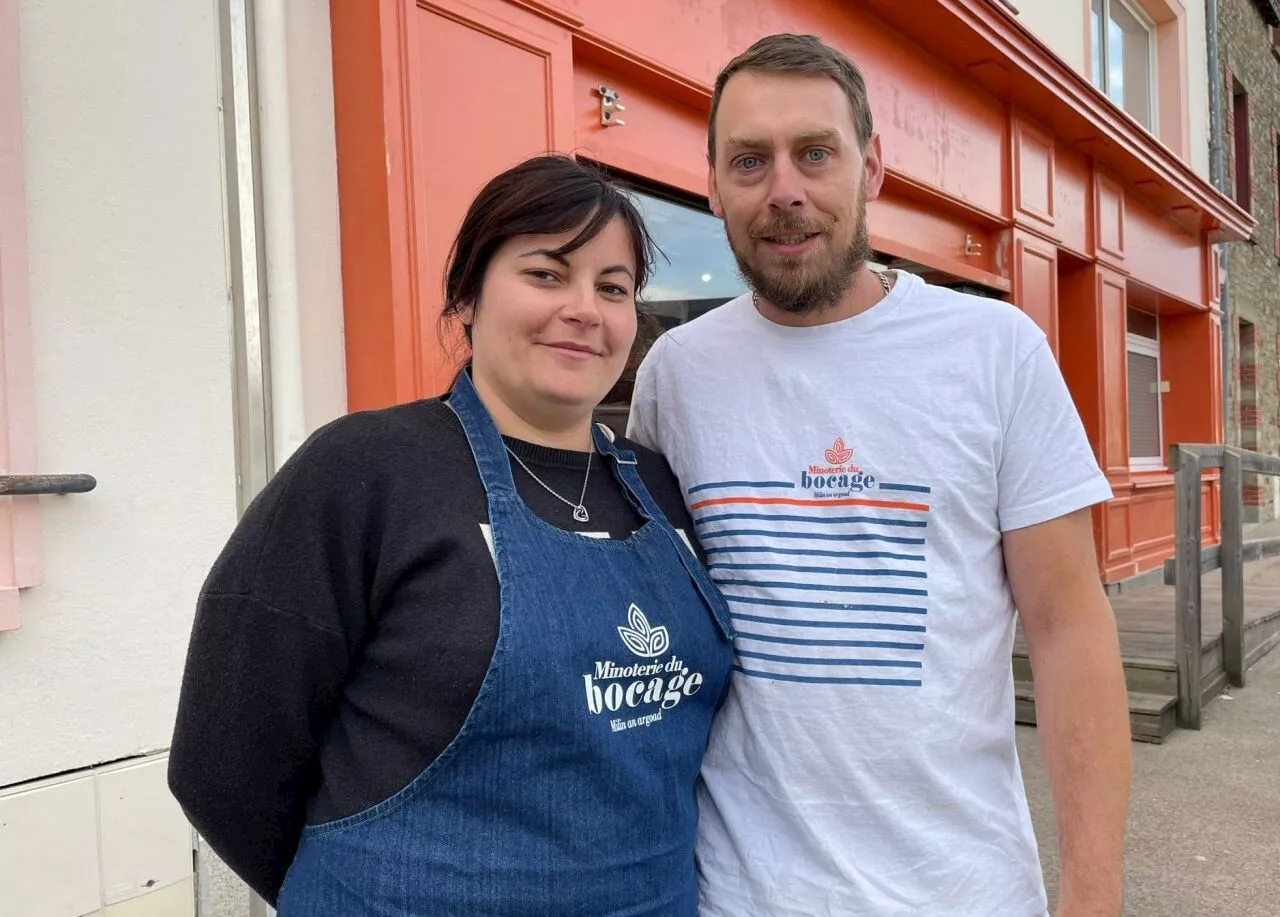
596 190 746 429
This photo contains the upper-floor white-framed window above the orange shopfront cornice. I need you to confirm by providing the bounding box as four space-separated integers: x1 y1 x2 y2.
1091 0 1156 132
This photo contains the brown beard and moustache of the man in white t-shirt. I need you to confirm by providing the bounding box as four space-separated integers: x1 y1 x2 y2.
724 188 872 315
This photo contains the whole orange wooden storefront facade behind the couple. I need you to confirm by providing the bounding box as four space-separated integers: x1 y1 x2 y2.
332 0 1252 581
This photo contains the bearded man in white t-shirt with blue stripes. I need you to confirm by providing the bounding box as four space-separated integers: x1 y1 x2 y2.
630 35 1129 917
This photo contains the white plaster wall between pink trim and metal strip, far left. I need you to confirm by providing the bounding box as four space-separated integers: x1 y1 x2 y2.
0 0 236 788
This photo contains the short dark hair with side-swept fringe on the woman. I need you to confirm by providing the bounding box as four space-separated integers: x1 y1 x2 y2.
440 155 657 341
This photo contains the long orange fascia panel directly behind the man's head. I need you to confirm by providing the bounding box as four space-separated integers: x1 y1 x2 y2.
550 0 1009 215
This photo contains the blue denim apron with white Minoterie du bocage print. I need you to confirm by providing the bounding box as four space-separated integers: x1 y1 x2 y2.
278 373 732 917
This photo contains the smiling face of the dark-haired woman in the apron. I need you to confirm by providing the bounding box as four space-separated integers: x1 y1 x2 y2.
463 218 636 423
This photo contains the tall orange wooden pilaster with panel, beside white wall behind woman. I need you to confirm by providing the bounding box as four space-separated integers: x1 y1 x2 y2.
330 0 573 410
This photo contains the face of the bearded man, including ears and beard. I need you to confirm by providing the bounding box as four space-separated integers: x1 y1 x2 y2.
710 70 883 315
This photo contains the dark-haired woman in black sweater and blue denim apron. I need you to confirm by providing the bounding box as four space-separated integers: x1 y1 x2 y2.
169 156 732 917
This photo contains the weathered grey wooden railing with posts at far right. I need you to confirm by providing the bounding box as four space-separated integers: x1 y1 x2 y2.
1165 443 1280 729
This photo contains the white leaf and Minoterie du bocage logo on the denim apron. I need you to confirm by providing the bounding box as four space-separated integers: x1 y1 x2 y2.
582 603 703 733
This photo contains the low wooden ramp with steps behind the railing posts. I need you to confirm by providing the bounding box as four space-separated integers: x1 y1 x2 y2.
1014 557 1280 743
